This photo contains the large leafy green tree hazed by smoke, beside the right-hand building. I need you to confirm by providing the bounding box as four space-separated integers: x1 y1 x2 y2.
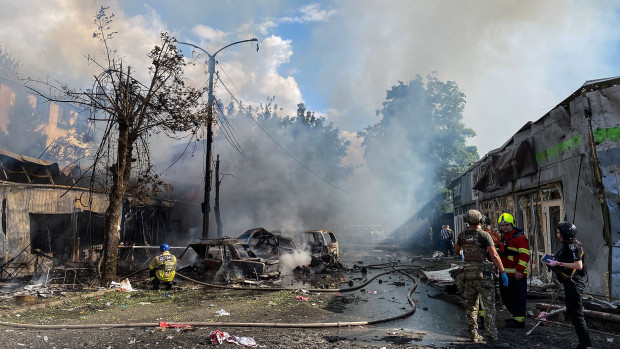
358 74 478 209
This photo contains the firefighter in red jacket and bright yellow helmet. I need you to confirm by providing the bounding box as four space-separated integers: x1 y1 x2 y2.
497 213 530 328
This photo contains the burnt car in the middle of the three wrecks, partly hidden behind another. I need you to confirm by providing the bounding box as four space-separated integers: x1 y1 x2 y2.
238 228 300 259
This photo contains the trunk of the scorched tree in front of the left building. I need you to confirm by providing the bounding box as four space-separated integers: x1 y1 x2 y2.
101 123 132 287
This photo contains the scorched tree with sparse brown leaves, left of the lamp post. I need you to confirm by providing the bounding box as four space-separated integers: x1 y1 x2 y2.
31 7 204 285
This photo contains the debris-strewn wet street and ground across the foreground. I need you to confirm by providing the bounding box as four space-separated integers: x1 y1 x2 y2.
1 249 617 348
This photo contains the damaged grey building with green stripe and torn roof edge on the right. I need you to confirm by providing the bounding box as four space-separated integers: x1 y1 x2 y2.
452 78 620 298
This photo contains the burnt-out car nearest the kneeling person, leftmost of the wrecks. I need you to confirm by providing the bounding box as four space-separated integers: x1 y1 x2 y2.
183 238 280 281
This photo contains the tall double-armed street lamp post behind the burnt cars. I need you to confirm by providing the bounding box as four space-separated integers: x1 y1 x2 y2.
179 38 258 240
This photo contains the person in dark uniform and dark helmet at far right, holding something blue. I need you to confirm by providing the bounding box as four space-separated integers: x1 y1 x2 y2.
547 222 592 348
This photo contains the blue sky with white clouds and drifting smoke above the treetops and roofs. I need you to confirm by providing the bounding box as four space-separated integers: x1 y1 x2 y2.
0 0 620 156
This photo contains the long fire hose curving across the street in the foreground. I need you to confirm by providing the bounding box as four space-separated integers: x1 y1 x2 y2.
0 264 418 330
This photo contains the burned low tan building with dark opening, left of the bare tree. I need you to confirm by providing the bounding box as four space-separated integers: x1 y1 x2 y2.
0 150 108 278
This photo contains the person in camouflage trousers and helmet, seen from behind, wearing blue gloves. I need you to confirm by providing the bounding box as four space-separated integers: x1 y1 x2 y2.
455 210 508 342
